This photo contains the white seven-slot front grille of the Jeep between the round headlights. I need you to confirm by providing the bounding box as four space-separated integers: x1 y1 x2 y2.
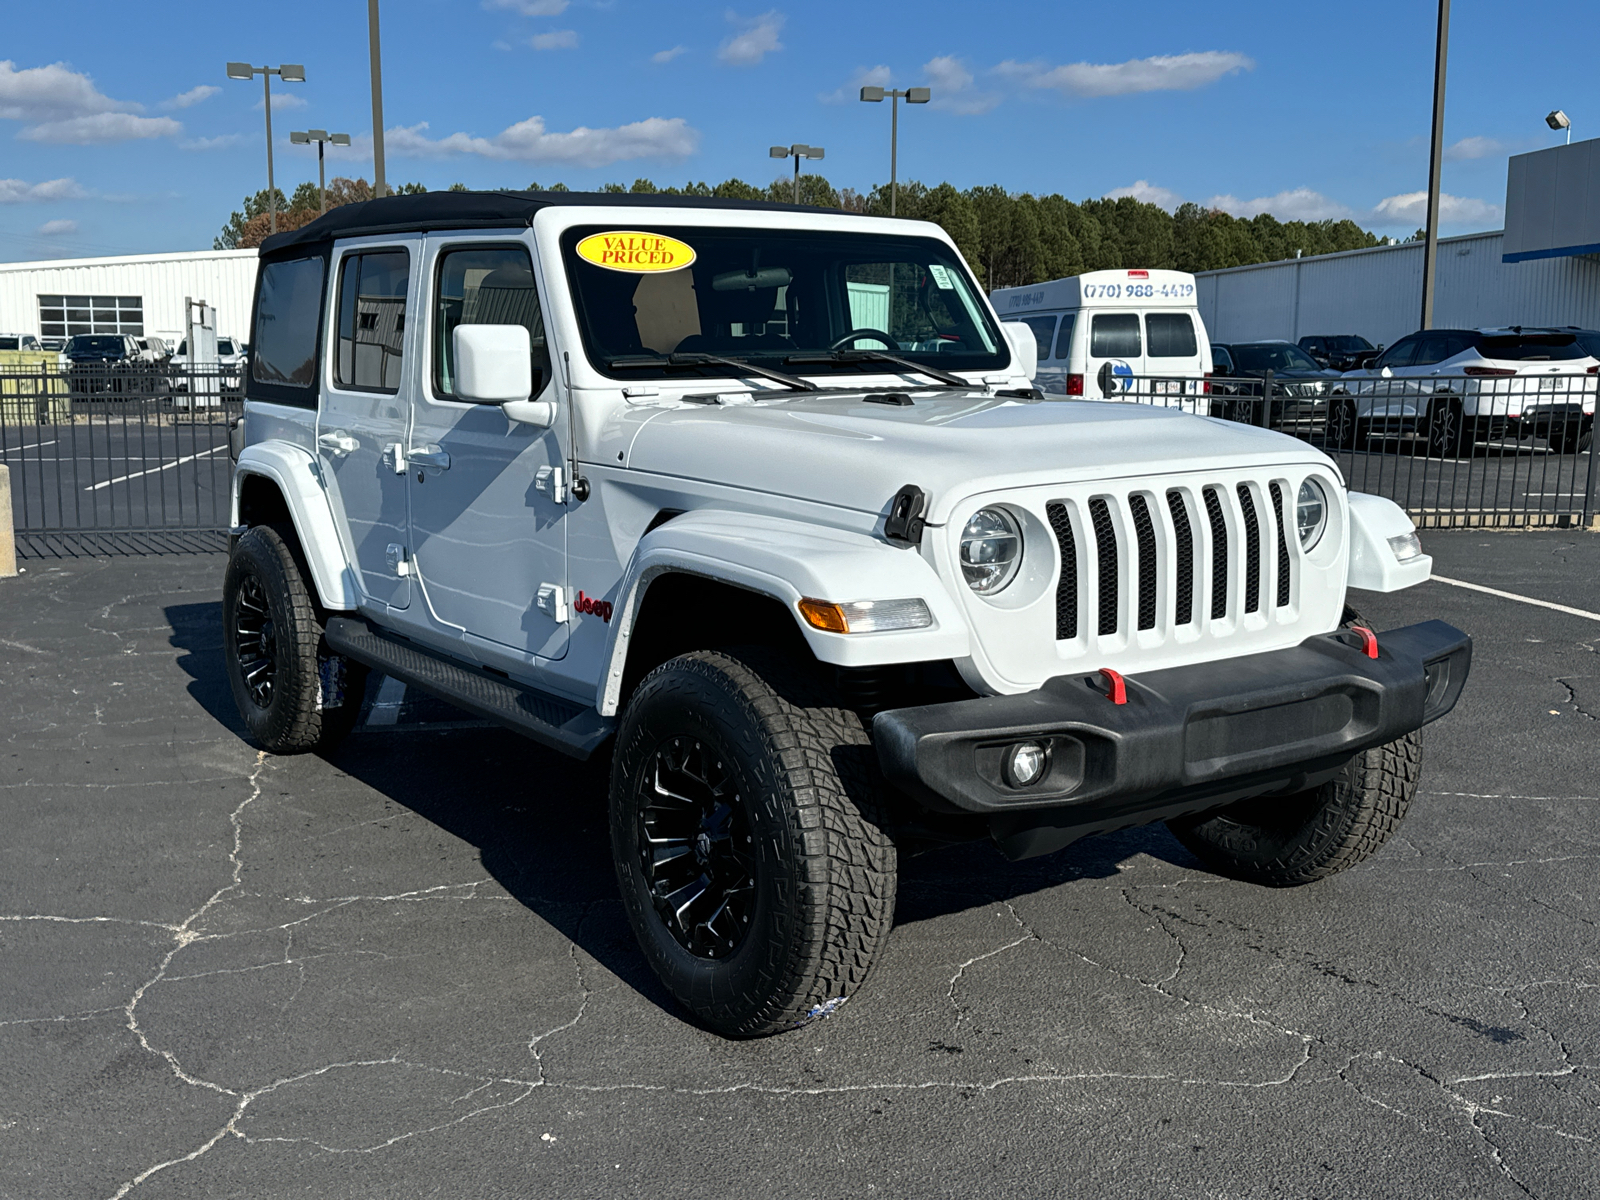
1045 480 1296 645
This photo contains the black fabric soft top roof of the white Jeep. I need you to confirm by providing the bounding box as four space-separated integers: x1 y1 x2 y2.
261 192 830 254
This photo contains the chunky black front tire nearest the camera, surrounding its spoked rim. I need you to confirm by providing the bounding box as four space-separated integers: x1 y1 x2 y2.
611 648 898 1037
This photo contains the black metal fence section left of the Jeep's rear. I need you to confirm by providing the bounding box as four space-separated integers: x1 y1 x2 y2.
0 363 243 546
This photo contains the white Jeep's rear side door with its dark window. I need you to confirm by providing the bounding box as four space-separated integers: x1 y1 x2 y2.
317 237 422 608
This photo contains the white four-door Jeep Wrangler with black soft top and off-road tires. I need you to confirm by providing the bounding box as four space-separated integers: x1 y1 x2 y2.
224 192 1470 1035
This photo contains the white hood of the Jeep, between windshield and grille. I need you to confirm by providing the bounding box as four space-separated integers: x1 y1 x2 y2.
627 392 1331 525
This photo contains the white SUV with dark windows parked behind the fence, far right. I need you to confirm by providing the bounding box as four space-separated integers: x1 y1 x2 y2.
1328 325 1600 458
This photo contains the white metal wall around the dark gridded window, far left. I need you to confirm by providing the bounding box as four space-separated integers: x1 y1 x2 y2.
0 250 256 341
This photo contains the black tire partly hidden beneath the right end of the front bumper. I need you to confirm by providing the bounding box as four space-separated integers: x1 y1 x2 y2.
1166 608 1422 888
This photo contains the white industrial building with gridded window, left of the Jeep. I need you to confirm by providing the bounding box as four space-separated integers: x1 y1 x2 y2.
0 250 256 346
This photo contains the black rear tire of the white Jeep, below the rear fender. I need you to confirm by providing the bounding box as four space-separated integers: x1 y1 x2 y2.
222 525 366 754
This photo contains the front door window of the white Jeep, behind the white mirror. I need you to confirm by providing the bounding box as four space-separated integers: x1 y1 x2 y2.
434 246 550 398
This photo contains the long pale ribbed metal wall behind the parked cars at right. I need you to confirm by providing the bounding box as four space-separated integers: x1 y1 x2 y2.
1195 230 1600 346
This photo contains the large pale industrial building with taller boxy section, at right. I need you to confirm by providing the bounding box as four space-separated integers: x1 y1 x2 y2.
1195 139 1600 346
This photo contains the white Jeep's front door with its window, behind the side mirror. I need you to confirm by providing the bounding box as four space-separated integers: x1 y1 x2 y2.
408 237 571 659
